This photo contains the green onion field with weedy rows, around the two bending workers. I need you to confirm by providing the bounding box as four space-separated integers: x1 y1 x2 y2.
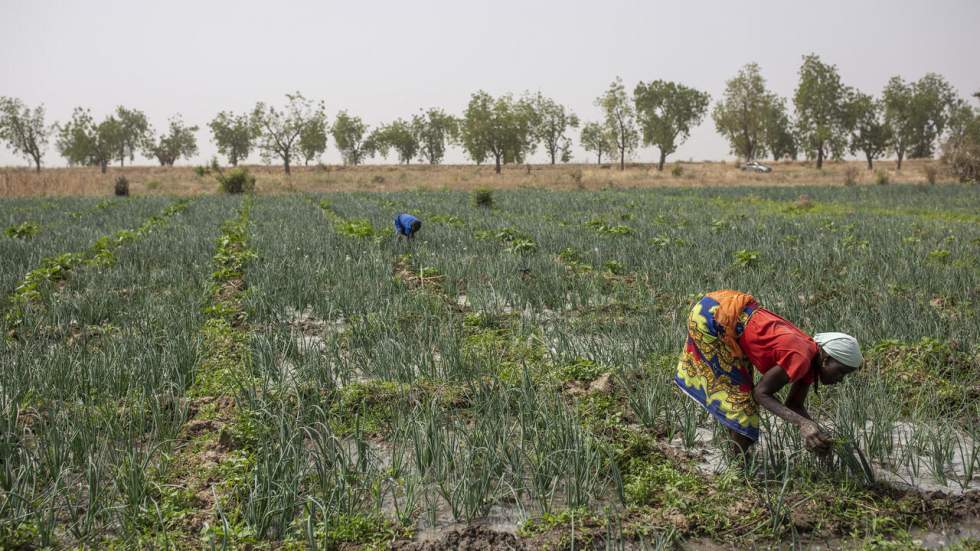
0 185 980 550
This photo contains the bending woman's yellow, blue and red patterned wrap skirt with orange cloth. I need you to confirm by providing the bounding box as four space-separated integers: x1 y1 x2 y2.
674 291 759 440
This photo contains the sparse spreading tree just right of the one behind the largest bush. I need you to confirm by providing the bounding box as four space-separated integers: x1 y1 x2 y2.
252 92 327 174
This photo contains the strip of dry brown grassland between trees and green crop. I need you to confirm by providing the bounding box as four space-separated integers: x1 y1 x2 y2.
0 160 952 197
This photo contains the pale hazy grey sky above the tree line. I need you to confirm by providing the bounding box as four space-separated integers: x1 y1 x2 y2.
0 0 980 166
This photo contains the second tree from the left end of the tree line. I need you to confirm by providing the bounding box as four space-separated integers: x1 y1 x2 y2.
56 107 123 174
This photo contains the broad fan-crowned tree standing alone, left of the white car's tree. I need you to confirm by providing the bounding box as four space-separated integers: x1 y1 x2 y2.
633 80 711 171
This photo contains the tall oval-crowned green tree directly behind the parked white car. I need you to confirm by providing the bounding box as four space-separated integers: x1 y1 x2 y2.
711 63 778 161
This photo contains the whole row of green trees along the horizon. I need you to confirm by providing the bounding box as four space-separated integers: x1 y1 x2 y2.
0 54 980 180
